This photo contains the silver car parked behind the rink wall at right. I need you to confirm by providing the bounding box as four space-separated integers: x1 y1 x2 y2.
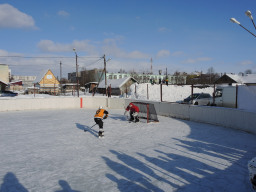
182 93 212 105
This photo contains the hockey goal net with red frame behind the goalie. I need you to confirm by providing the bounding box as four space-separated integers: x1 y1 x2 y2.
132 102 159 123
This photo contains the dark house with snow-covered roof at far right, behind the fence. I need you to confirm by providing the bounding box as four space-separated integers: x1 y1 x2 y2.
214 74 256 85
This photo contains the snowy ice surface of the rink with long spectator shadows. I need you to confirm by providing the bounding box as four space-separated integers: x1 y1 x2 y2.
0 109 256 192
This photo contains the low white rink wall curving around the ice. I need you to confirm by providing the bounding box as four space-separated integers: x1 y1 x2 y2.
0 96 256 134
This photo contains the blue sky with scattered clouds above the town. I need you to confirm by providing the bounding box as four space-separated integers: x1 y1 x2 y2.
0 0 256 76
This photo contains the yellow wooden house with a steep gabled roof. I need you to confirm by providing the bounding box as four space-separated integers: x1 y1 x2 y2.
34 69 60 95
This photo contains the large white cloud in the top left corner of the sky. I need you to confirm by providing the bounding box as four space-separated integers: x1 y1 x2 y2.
0 4 36 29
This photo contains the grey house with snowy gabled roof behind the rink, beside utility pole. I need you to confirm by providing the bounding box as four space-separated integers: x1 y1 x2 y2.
98 77 138 95
